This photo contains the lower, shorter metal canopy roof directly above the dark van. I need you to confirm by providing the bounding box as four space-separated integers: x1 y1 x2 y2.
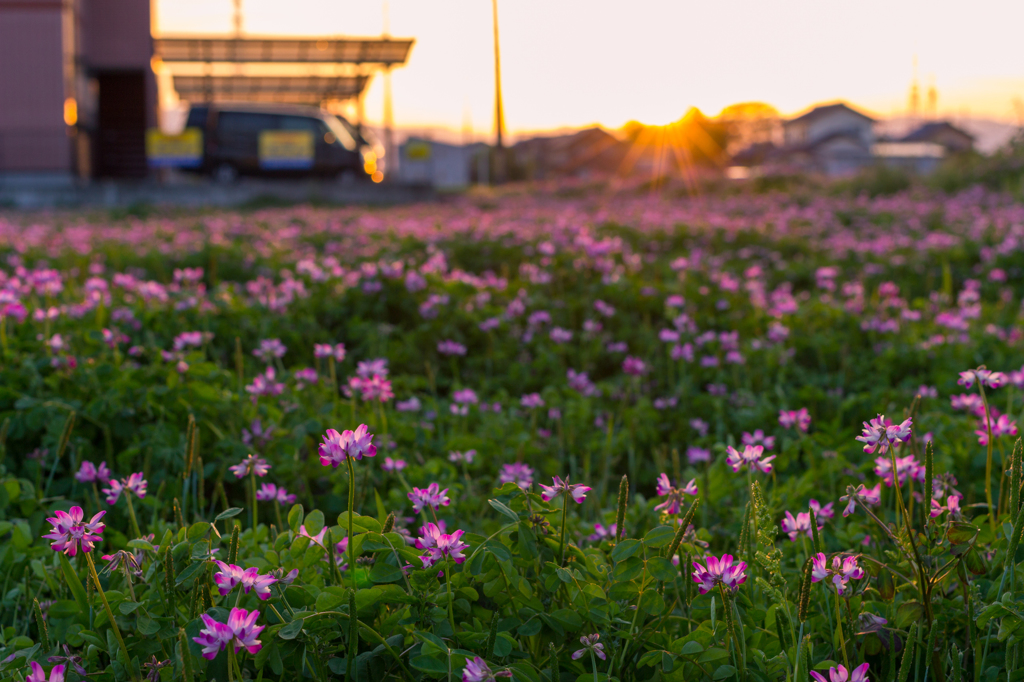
174 76 370 104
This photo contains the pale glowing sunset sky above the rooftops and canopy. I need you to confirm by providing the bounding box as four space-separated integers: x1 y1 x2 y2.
156 0 1024 135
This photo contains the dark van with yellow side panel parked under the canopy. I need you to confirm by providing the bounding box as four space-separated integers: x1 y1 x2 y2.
185 103 384 182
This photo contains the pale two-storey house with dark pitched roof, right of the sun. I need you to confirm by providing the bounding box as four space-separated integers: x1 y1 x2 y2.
770 102 874 175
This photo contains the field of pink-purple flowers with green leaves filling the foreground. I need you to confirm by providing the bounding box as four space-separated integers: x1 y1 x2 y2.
0 184 1024 682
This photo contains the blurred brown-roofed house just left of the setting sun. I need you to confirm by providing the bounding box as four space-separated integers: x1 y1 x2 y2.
512 127 628 180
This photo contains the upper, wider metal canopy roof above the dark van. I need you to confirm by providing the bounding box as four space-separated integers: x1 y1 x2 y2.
153 36 414 66
